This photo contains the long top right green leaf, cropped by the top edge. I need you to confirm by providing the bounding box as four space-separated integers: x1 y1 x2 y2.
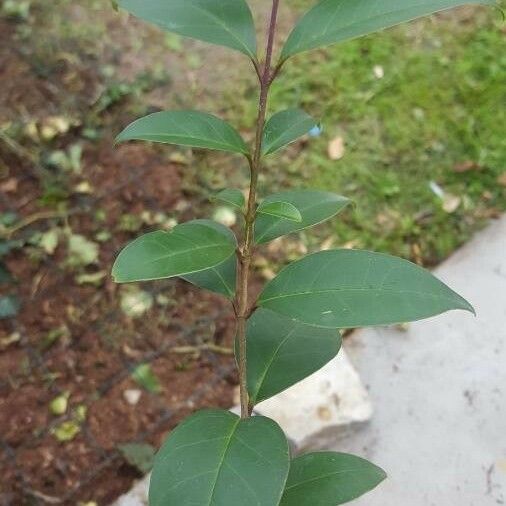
281 0 496 60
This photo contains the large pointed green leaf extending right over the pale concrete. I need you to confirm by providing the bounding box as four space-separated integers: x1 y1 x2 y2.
258 250 474 328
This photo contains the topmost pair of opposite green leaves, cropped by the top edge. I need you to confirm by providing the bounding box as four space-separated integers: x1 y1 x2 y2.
118 0 497 61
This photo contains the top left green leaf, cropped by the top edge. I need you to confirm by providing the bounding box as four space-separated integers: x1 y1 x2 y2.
118 0 257 59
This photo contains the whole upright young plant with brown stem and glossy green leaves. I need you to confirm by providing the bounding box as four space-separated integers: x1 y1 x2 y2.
113 0 493 506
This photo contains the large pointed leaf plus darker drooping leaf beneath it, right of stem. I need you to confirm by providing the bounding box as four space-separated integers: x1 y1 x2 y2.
243 250 474 405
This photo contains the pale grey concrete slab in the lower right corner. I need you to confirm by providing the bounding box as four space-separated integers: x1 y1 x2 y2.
335 216 506 506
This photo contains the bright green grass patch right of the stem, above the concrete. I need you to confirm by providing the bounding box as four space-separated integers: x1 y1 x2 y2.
222 2 506 265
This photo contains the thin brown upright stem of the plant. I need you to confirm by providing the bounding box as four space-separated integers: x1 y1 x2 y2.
236 0 280 418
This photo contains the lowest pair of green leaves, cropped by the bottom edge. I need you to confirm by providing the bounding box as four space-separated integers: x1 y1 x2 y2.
149 410 385 506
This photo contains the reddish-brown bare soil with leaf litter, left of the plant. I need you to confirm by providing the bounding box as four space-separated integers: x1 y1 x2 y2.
0 15 237 506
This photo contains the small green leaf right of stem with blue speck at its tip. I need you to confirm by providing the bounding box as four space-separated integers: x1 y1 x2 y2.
262 109 316 155
